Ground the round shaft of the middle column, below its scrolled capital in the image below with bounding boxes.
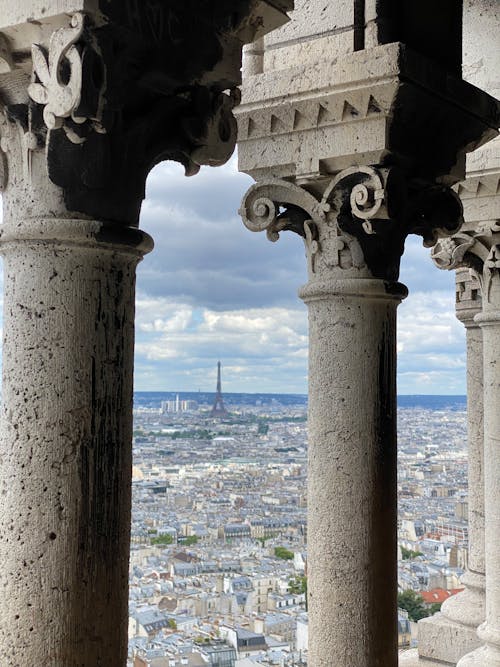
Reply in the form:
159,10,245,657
301,279,404,667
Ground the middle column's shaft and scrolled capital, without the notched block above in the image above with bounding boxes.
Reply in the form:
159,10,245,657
241,166,461,667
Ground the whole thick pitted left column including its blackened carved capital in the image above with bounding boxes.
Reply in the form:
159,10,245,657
0,0,290,667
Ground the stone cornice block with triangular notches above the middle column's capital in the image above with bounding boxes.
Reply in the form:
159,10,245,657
237,44,500,185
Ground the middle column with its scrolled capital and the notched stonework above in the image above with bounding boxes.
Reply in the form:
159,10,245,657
237,0,497,667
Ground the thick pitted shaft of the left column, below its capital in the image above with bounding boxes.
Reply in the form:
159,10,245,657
0,220,147,667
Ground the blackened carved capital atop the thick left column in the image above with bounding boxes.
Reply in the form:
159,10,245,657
0,0,292,225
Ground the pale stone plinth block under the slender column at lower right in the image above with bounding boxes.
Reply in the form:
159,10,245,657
418,614,481,665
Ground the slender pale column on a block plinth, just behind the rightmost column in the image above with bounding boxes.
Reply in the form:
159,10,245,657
418,268,485,665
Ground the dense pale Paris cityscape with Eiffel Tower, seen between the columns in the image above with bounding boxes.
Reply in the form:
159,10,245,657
129,374,468,667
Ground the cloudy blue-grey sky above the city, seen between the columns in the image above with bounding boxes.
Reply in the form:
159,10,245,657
0,157,466,394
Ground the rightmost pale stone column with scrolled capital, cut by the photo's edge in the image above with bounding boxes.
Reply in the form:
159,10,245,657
433,219,500,667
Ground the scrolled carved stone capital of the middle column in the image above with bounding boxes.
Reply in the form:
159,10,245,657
240,166,462,281
